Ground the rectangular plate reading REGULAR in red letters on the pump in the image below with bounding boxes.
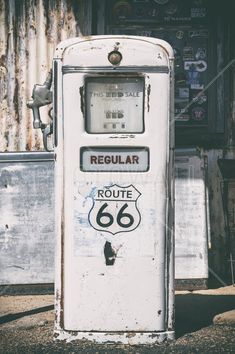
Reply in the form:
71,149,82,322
80,147,149,172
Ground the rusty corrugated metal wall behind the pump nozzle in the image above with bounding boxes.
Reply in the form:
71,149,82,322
0,0,91,152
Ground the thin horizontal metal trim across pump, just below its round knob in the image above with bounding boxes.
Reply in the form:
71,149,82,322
62,65,170,74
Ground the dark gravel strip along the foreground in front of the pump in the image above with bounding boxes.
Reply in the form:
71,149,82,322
0,324,235,354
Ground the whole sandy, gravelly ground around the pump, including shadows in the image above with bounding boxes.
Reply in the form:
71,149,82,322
0,286,235,354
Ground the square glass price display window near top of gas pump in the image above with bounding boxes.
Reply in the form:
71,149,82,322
85,77,144,134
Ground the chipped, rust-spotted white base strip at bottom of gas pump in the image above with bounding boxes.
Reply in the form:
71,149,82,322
54,330,175,345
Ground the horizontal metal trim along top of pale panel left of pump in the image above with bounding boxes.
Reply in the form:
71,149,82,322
0,151,55,163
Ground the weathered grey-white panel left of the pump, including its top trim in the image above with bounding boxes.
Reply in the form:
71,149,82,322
0,152,55,285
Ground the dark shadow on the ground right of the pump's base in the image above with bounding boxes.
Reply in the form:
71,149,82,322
175,294,235,338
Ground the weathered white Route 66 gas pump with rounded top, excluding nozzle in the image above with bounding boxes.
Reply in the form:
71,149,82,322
53,36,174,344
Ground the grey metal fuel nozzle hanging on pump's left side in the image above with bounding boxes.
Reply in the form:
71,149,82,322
27,70,53,151
